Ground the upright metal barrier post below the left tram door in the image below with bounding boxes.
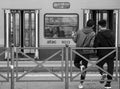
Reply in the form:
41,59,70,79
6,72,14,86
10,47,14,89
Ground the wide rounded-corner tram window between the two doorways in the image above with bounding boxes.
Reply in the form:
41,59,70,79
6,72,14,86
44,14,79,39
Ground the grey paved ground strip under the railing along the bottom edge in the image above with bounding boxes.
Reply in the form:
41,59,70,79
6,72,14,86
0,82,120,89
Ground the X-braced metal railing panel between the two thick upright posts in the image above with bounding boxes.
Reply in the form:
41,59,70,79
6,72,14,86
15,47,64,82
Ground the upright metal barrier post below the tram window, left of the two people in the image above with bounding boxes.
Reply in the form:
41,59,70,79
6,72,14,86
65,45,69,89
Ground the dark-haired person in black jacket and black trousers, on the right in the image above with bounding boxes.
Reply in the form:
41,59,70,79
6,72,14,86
94,20,115,88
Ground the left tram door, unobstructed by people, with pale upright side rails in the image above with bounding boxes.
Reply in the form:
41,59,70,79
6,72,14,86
4,9,39,57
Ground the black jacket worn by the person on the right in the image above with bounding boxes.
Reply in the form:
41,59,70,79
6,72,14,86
94,29,115,57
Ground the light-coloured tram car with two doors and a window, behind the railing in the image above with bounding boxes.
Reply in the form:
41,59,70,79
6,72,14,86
0,0,120,60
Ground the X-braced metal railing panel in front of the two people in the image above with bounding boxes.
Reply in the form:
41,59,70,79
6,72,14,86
70,47,118,81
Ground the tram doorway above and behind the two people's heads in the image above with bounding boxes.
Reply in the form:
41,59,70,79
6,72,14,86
83,9,118,35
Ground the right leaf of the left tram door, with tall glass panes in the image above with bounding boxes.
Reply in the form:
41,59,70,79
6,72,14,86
24,13,35,47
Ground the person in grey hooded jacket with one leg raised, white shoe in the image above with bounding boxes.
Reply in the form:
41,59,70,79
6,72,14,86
73,19,95,88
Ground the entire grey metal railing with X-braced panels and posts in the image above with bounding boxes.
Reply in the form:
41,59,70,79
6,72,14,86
0,45,118,89
